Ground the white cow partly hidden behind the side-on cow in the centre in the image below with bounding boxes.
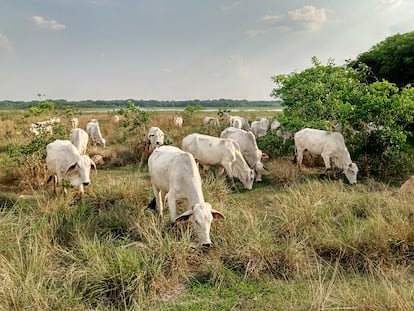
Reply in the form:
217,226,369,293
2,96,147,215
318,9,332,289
220,127,268,181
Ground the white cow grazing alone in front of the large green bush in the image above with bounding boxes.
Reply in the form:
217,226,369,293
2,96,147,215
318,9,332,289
294,128,358,184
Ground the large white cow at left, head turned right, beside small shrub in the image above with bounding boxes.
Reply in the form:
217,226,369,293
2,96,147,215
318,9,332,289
46,139,96,196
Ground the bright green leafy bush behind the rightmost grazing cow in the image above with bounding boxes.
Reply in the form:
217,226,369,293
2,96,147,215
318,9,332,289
273,58,414,177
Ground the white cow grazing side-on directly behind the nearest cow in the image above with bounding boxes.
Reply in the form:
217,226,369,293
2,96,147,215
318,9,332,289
182,133,254,190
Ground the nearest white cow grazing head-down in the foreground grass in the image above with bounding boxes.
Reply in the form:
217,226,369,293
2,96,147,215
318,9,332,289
148,146,224,247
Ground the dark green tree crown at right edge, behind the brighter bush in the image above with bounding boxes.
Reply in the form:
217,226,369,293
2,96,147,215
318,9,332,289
351,31,414,87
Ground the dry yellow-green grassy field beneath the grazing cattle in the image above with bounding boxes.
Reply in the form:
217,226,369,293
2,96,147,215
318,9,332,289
0,111,414,311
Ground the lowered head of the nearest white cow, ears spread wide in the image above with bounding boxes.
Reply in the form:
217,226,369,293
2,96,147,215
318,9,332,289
175,203,225,247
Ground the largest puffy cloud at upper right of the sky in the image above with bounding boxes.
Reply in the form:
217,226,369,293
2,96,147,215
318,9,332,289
288,5,328,32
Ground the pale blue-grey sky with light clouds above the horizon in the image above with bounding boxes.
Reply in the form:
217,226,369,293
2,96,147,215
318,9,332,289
0,0,414,101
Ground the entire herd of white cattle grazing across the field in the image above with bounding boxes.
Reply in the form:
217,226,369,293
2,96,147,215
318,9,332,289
30,114,358,246
